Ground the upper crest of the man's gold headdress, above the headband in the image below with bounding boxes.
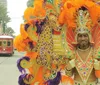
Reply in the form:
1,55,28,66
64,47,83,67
76,7,92,32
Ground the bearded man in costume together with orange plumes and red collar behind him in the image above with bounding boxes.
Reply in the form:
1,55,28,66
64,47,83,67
59,0,100,85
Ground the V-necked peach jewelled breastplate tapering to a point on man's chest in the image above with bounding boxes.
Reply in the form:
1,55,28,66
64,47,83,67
75,49,93,84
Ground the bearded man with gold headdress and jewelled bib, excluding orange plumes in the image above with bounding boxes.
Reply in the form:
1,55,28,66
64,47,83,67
66,7,96,85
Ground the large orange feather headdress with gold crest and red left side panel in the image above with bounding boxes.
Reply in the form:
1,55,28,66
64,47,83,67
59,0,100,49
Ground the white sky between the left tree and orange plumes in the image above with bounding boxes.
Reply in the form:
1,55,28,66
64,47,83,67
7,0,28,35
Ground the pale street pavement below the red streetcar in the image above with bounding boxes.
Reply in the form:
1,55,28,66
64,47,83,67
0,51,25,85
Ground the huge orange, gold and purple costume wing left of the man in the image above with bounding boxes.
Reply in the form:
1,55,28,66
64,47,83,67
14,0,72,85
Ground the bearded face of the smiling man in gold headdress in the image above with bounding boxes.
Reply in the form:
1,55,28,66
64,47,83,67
77,33,89,48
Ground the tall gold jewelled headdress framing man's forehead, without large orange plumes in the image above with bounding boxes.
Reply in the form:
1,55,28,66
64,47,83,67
75,6,93,39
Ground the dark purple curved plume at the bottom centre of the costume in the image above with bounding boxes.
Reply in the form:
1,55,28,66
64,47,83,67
46,71,61,85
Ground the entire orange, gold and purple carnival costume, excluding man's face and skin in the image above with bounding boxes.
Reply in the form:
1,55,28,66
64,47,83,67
14,0,100,85
